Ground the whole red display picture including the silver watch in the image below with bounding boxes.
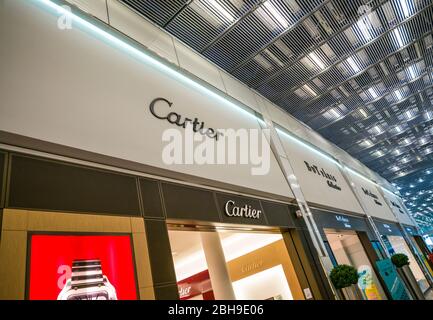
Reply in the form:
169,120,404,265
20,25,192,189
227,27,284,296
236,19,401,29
27,234,137,300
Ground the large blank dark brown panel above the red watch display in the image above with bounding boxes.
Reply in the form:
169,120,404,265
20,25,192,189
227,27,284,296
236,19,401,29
7,155,140,216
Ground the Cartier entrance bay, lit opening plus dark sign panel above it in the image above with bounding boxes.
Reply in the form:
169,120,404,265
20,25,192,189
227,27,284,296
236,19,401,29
162,183,330,300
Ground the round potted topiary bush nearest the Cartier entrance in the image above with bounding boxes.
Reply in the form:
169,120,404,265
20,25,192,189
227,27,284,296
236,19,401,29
329,264,362,300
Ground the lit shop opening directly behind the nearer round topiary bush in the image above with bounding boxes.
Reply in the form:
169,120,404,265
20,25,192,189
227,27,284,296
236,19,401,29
324,229,387,300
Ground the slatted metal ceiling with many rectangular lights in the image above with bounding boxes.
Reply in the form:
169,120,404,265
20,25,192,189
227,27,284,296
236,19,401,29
122,0,433,230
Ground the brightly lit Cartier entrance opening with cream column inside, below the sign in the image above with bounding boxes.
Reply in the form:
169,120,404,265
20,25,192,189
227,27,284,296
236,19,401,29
169,225,303,300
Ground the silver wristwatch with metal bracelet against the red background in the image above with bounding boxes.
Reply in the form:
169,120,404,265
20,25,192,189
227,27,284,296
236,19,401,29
57,259,117,300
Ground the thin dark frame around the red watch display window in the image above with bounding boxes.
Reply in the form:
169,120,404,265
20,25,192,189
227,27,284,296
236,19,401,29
24,231,140,300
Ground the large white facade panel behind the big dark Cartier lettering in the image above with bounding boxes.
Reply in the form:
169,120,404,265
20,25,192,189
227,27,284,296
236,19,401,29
0,1,293,198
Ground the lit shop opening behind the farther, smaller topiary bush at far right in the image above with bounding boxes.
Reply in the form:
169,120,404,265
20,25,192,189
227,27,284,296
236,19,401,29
382,235,429,292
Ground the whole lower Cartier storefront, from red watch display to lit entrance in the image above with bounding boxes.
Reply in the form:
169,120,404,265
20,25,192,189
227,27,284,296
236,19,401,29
0,151,329,300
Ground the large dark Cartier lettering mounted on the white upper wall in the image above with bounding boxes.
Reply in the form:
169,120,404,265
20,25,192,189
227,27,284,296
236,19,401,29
149,98,223,141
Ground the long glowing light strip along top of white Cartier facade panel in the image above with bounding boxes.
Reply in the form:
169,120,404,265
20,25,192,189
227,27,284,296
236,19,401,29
36,0,261,125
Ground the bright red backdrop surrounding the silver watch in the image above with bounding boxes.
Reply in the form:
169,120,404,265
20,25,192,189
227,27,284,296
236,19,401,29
28,235,137,300
